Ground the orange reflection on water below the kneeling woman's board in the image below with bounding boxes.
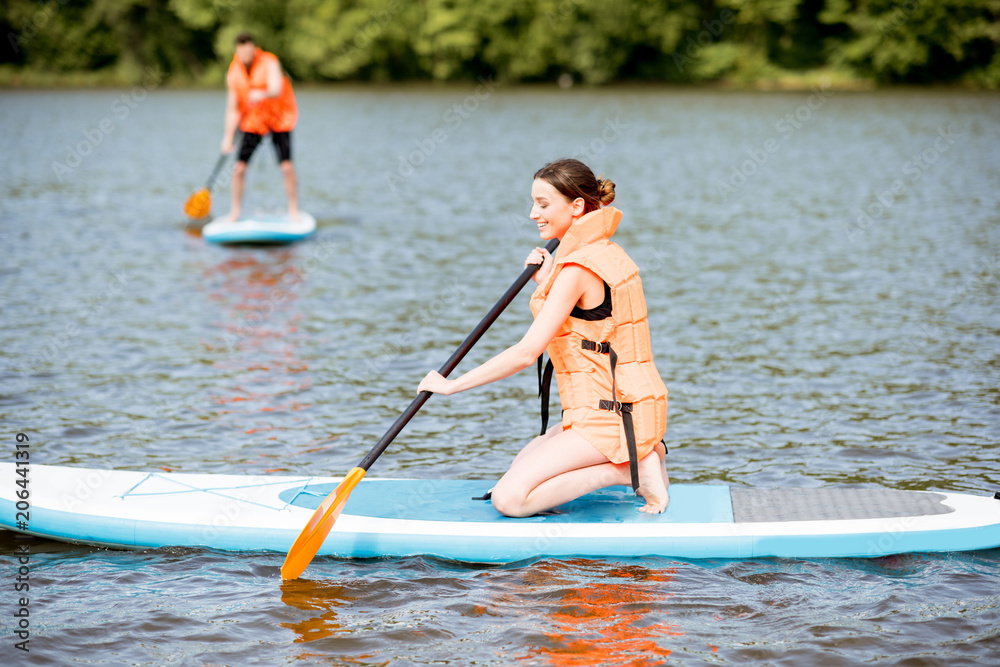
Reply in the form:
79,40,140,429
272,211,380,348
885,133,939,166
520,561,684,667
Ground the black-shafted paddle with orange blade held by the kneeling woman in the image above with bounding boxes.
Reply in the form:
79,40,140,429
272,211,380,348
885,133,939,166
281,239,559,581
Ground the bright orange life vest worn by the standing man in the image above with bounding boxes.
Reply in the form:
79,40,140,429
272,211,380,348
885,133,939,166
226,47,299,135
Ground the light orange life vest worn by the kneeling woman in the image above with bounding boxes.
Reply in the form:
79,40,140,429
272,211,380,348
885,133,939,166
531,207,667,463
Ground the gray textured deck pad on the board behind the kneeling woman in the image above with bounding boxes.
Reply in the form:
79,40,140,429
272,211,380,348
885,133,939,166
730,487,955,522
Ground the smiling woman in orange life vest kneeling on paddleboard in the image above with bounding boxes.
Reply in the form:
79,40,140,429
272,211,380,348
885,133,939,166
418,159,670,517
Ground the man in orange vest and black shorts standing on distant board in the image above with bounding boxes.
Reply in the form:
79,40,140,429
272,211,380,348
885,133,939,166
222,32,299,220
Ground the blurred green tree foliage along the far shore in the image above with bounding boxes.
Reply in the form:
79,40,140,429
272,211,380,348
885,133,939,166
0,0,1000,89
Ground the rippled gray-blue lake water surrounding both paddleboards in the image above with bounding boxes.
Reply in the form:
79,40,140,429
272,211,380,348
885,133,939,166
0,82,1000,666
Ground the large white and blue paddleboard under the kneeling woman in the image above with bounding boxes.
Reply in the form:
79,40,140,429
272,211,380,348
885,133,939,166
0,463,1000,563
